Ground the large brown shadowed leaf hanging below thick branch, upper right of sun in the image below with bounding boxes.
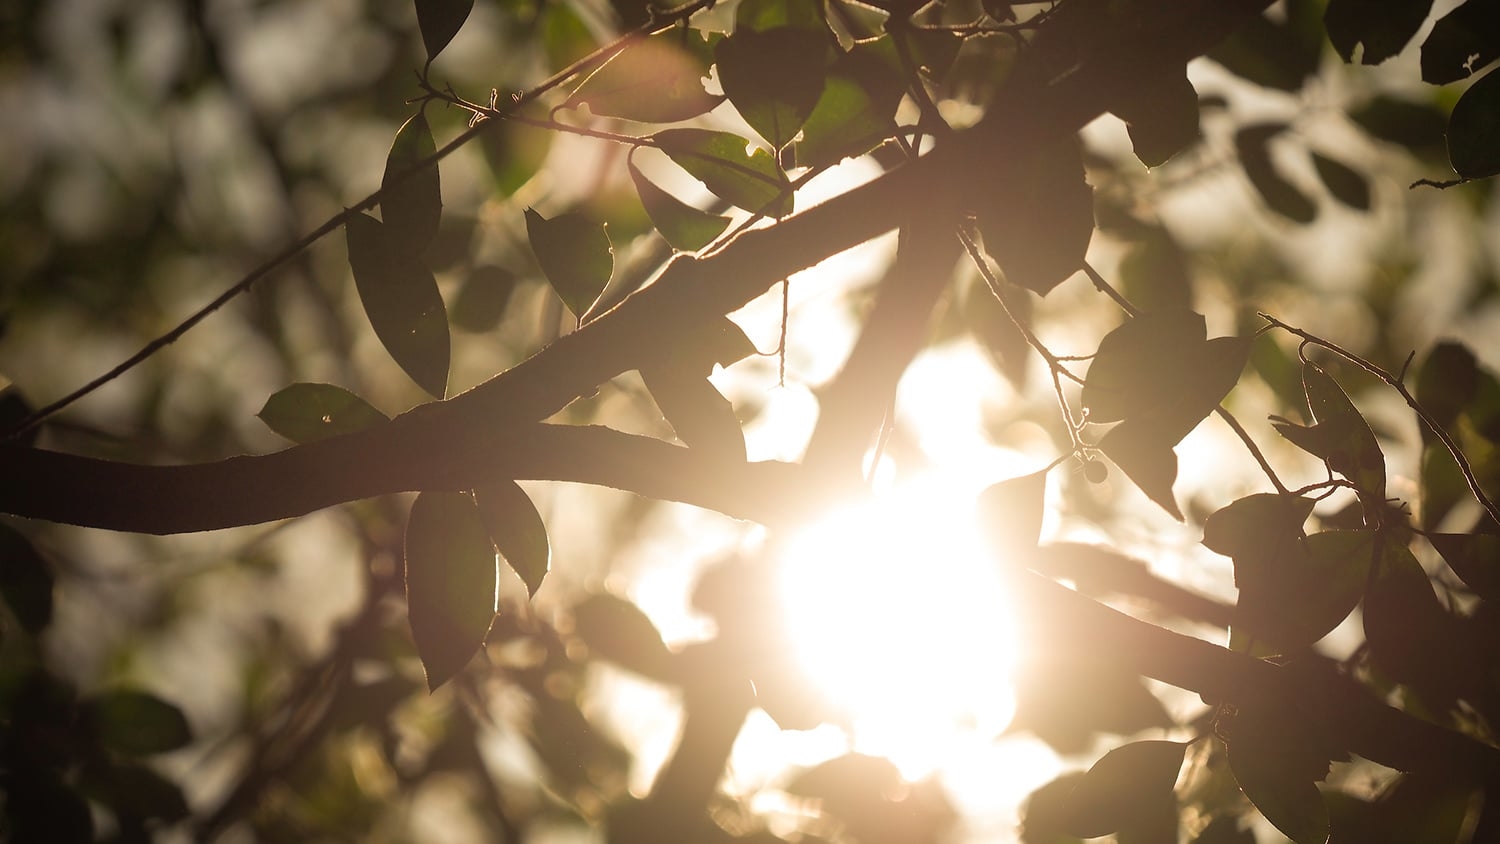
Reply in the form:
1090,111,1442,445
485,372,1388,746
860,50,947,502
980,138,1094,295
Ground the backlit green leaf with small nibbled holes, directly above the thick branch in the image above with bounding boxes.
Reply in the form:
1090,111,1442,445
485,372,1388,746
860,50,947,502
651,129,792,217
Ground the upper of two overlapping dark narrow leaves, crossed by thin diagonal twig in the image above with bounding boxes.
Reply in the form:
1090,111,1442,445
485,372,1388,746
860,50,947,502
380,111,443,256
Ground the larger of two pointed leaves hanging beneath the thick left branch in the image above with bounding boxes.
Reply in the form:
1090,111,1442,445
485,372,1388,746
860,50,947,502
405,490,500,691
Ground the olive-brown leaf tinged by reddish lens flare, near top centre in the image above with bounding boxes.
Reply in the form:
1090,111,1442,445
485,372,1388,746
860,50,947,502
563,30,722,123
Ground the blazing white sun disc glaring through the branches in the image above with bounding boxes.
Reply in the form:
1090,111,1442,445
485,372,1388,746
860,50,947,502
782,467,1016,778
